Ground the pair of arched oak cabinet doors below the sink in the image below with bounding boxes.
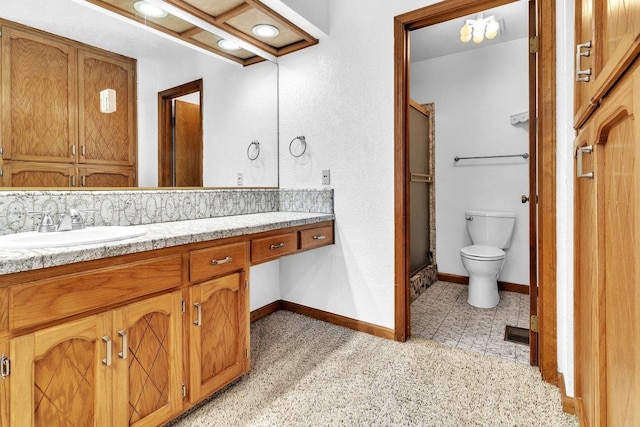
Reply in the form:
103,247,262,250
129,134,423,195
10,291,182,426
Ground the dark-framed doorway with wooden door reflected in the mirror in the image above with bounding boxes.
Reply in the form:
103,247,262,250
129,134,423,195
158,79,203,187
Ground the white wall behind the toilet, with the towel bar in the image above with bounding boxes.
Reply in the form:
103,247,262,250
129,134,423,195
410,38,529,285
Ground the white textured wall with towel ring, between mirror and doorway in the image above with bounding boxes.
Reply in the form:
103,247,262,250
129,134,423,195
279,0,442,328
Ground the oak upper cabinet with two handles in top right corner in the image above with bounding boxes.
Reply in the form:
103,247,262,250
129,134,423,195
574,0,640,129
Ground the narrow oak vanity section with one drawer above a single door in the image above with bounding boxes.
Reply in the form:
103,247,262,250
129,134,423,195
186,242,250,404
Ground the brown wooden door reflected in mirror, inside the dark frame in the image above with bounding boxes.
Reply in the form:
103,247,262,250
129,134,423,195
174,100,202,187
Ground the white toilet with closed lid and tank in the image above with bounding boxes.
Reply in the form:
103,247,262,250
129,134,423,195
460,211,516,308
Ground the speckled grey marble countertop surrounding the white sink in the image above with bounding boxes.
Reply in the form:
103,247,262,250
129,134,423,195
0,212,335,275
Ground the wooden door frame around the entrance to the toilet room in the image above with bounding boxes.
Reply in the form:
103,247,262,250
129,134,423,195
394,0,558,384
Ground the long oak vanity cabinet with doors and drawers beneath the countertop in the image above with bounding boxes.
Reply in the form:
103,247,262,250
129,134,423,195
0,221,333,427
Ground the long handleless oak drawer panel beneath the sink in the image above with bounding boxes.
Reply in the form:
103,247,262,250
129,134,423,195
9,255,182,329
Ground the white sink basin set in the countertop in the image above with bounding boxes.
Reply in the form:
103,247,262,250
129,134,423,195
0,225,147,249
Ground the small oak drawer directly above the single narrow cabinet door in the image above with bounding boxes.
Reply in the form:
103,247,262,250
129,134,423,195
189,243,247,282
